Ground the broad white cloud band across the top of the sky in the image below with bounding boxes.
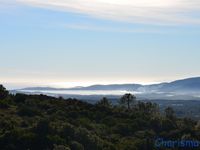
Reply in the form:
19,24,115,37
12,0,200,24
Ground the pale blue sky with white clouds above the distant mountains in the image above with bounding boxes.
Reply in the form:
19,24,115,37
0,0,200,89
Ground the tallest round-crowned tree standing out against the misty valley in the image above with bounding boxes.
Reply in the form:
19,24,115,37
119,93,136,110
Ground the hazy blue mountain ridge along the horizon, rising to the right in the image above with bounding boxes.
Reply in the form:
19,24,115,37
20,77,200,93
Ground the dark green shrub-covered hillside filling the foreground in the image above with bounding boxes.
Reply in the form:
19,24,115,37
0,86,200,150
